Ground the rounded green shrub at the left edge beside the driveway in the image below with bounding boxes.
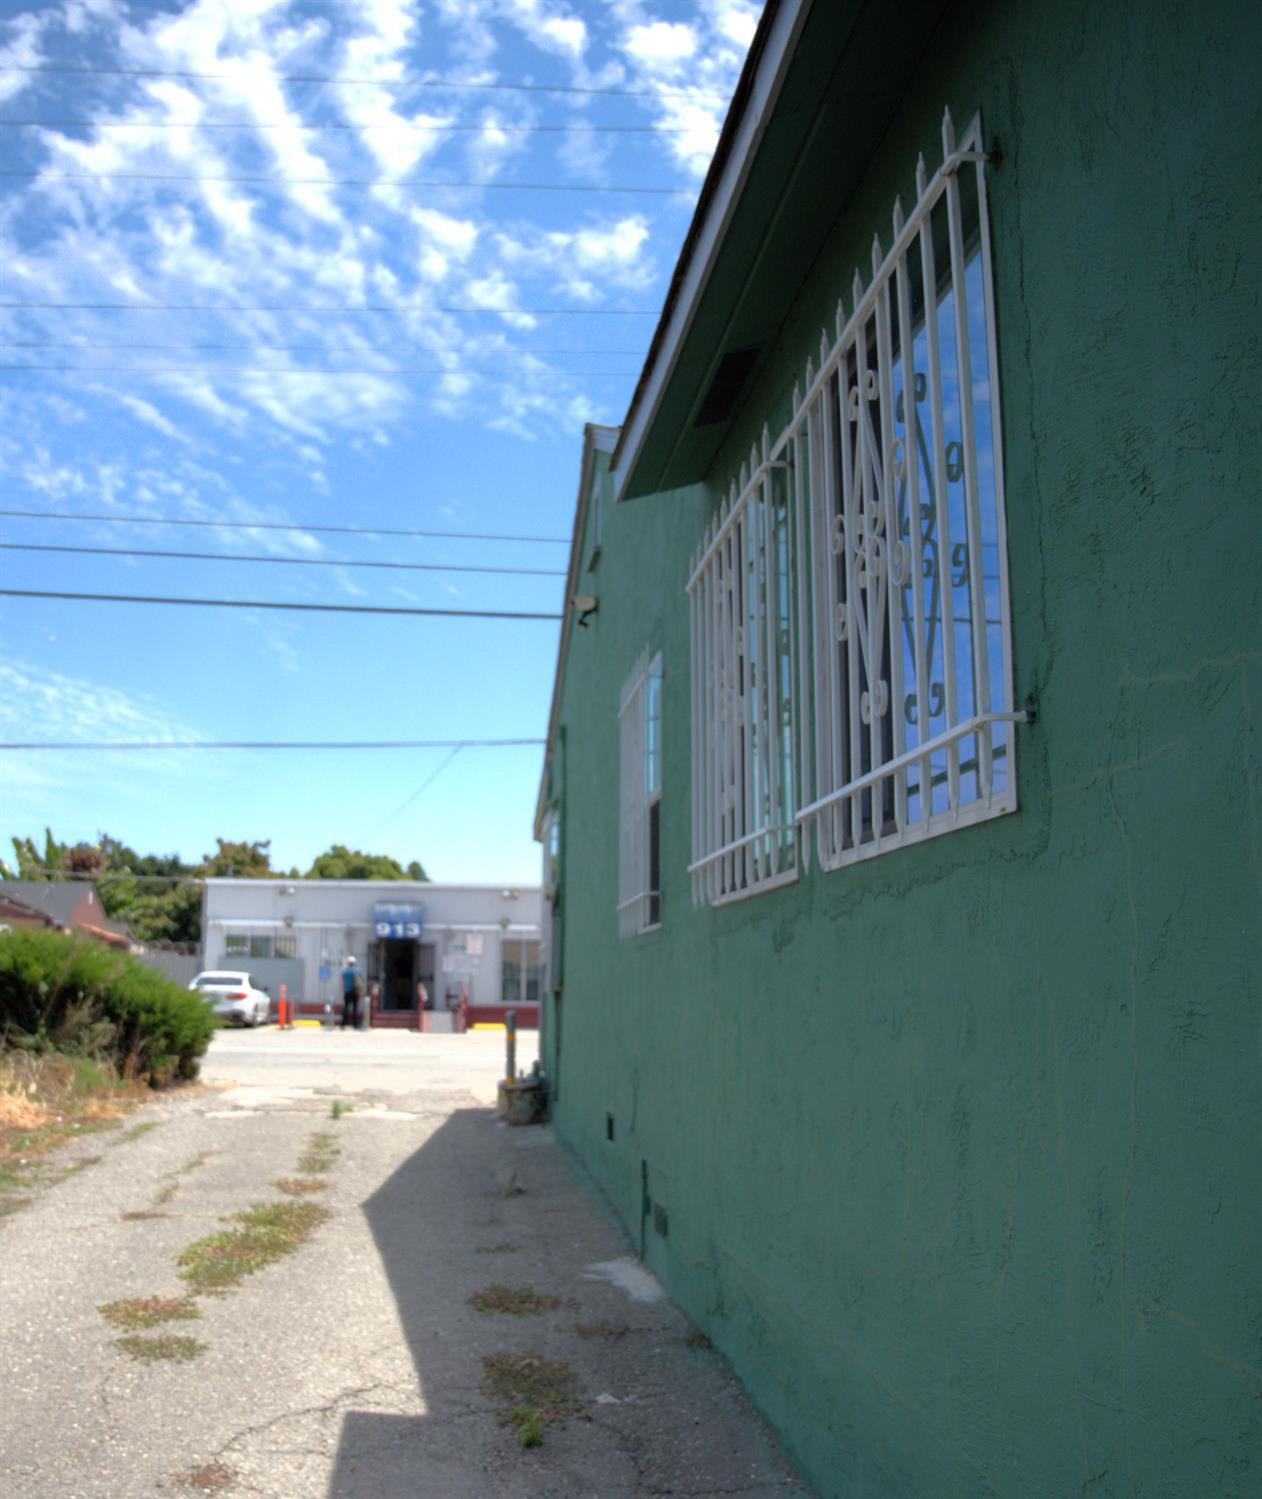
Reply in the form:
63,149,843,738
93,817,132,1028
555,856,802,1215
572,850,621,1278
0,928,214,1085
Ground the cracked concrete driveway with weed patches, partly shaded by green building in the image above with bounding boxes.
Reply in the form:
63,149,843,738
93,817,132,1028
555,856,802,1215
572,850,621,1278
0,1030,805,1499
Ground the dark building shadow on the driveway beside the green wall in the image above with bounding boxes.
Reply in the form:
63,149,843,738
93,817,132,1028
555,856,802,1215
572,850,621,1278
328,1108,803,1499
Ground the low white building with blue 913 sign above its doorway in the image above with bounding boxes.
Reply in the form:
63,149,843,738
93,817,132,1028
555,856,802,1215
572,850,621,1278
202,878,543,1030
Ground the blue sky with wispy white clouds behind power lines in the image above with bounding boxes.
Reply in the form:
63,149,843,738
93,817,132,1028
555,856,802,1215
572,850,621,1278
0,0,760,883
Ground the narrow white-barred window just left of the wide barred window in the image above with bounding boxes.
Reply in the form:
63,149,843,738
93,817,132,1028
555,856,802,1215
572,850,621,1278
618,651,661,937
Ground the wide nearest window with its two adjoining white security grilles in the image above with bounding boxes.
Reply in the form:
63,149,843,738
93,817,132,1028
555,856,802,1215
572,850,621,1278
689,112,1025,902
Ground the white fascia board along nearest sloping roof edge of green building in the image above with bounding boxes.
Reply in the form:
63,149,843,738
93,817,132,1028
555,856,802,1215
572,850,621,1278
613,0,811,502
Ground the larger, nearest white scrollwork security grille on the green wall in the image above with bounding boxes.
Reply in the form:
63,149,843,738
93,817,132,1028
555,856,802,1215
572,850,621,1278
781,112,1025,869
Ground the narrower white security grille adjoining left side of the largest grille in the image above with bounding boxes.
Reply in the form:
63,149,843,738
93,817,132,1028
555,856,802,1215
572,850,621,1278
688,430,800,905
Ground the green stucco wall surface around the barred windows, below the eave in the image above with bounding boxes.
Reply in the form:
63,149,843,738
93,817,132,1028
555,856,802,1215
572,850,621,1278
547,0,1262,1499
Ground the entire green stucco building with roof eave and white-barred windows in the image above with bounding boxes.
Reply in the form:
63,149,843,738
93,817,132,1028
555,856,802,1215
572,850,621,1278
537,0,1262,1499
